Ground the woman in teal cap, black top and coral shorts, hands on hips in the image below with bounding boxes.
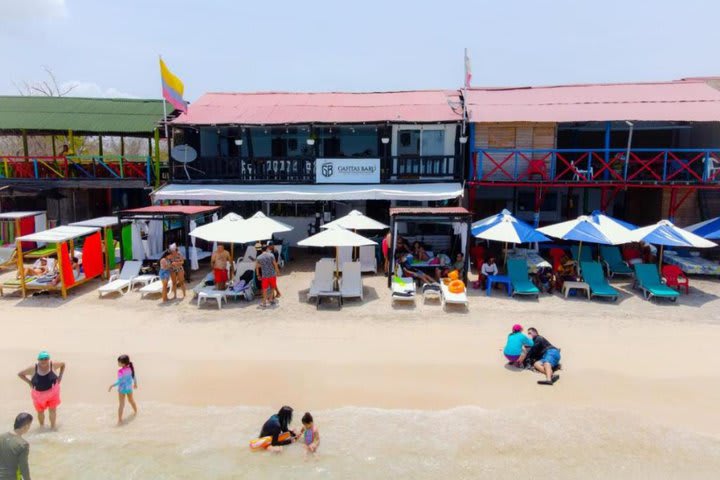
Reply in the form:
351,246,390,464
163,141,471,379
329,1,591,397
18,350,65,429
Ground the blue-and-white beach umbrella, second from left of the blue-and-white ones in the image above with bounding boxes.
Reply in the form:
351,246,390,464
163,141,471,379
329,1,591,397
538,211,634,265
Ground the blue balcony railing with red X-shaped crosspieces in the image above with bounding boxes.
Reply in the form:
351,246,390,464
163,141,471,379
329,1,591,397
470,148,720,184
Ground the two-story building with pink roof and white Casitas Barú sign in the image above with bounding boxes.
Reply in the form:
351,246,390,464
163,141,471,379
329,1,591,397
154,90,468,244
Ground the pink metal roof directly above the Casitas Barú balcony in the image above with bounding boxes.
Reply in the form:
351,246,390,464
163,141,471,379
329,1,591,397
172,90,462,125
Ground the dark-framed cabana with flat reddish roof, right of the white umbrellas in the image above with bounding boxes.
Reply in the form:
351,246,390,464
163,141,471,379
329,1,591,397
388,207,472,287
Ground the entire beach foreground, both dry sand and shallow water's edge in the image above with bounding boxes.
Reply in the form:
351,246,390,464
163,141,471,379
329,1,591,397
0,260,720,479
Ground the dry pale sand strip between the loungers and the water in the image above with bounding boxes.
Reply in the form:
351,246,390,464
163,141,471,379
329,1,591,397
0,255,720,478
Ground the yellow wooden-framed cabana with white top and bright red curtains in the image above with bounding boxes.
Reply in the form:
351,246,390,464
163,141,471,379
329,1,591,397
15,226,103,298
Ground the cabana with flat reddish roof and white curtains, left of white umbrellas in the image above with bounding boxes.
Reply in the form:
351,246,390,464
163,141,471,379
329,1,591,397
118,205,220,280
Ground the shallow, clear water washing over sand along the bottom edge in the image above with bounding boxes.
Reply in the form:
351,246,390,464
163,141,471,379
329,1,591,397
9,404,720,480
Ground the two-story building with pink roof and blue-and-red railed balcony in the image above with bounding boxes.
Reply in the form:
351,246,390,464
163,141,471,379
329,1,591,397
464,78,720,225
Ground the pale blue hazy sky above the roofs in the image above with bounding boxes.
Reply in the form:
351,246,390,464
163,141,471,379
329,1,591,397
0,0,720,101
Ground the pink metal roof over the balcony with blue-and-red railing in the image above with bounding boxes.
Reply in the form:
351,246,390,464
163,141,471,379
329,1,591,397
465,79,720,122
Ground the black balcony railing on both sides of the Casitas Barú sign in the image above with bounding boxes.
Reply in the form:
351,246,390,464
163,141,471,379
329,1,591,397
177,155,463,183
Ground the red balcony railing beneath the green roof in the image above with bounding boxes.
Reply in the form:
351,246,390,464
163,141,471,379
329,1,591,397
0,155,153,185
